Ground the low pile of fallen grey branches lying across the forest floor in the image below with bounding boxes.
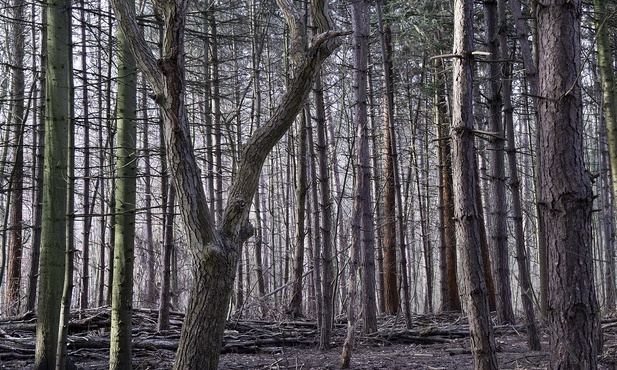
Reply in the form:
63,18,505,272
0,307,478,369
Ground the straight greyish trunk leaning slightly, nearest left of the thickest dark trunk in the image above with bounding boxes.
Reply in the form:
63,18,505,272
450,0,497,370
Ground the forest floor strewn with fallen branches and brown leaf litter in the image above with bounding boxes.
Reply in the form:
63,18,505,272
0,309,617,370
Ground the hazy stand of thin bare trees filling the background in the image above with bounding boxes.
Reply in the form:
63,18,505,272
0,0,617,368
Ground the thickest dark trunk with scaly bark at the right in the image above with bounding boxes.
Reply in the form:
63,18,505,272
538,0,602,369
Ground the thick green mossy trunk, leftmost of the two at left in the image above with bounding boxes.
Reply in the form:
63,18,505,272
34,0,72,370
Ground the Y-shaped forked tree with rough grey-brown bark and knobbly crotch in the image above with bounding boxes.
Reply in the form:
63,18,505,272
112,0,341,369
